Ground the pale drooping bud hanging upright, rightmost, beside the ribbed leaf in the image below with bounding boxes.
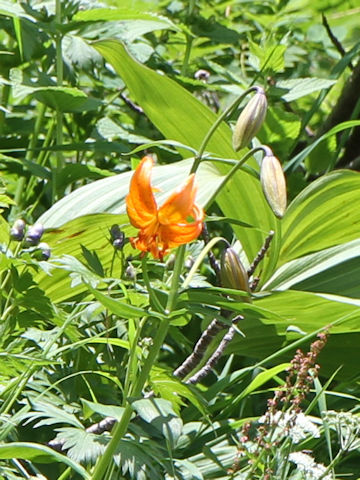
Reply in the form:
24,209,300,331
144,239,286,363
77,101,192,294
260,154,287,218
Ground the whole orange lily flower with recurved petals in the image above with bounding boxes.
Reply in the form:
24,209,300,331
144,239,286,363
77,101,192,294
126,156,204,260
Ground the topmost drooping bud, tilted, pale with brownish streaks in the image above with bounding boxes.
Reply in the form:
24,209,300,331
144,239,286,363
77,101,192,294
233,87,267,152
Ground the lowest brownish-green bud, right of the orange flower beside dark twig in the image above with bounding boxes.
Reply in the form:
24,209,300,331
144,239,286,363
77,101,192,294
220,247,251,302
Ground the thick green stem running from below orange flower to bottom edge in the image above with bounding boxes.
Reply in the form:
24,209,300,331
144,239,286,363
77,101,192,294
91,245,185,480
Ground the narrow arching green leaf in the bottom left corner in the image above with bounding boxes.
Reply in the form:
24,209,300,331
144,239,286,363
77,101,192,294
0,442,90,480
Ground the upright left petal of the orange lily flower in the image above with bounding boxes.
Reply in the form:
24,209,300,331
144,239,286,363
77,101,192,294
126,156,157,228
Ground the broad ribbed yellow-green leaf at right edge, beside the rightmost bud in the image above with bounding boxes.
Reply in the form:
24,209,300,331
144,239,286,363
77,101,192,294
279,170,360,265
